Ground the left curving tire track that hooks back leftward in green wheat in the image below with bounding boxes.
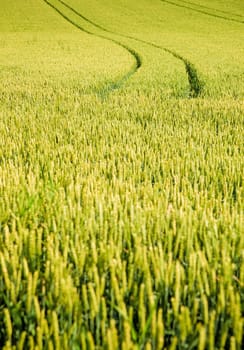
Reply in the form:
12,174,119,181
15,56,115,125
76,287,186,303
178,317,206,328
43,0,142,97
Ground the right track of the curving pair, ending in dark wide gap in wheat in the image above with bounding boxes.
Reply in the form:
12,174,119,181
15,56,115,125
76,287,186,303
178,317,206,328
55,0,204,98
